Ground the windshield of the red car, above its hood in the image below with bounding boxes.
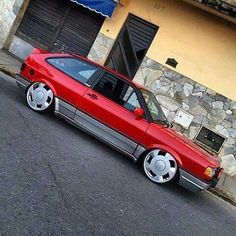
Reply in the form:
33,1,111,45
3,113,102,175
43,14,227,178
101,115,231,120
141,89,168,124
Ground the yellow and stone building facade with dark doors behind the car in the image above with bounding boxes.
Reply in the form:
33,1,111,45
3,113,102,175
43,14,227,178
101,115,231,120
0,0,236,199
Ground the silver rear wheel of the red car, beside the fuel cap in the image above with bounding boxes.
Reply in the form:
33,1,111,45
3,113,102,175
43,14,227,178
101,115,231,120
26,82,53,111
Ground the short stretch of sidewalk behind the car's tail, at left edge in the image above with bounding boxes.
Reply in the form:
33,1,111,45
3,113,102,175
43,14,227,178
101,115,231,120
0,50,22,77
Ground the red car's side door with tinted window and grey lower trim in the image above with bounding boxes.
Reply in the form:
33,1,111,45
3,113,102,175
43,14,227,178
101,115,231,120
75,72,149,154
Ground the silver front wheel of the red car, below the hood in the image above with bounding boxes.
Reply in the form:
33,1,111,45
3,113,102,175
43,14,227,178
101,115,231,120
143,149,178,184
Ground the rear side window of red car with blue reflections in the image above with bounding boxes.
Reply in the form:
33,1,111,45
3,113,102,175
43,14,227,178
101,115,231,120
47,57,98,84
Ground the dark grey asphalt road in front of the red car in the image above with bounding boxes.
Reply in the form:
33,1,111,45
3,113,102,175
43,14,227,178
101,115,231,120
0,74,236,236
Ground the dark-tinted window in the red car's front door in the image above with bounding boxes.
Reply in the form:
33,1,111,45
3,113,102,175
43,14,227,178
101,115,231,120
94,73,140,111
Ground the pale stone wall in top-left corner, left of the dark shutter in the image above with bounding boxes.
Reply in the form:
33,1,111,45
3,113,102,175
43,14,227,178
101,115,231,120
0,0,23,48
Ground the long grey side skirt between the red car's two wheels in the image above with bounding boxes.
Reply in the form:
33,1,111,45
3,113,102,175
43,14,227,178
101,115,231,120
55,98,146,161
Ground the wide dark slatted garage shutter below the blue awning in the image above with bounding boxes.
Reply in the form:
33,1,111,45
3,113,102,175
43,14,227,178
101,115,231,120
17,0,105,56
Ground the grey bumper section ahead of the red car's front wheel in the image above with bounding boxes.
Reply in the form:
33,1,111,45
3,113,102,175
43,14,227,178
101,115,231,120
179,169,210,192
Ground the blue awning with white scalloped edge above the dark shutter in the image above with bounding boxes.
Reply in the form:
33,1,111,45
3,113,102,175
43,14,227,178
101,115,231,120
71,0,117,18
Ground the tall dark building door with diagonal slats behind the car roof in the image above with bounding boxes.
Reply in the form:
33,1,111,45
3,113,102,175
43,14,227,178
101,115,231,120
105,14,159,80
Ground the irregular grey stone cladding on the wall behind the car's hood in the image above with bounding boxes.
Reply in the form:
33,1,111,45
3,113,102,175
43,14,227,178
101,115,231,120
134,57,236,176
